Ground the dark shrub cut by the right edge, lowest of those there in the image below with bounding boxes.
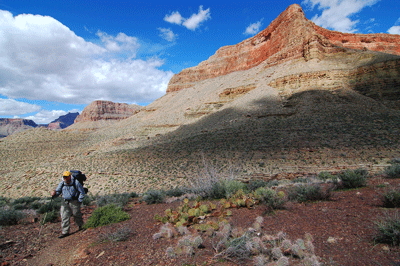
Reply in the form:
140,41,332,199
375,211,400,245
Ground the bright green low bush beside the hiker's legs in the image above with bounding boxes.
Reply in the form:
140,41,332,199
84,204,129,229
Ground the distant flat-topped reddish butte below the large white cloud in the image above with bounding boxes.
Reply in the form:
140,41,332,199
75,101,141,123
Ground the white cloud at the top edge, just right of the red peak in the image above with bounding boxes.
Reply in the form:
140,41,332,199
302,0,379,32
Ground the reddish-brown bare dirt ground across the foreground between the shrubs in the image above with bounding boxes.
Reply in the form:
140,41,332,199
0,177,400,266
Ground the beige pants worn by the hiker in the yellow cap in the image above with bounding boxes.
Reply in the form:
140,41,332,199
60,200,83,234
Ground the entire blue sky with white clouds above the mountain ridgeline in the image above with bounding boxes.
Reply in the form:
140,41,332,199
0,0,400,124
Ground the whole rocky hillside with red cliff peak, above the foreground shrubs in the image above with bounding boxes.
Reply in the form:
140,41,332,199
0,5,400,200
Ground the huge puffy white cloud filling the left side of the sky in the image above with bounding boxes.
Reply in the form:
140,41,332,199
0,10,173,109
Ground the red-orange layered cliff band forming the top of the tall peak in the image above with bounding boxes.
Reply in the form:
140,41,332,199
167,4,400,93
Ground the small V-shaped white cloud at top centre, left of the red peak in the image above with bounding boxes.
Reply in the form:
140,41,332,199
164,6,211,31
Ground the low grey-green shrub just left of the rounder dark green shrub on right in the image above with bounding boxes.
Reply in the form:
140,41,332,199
287,184,331,202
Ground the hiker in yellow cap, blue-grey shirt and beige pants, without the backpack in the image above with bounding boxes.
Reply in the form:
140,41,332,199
51,171,85,238
